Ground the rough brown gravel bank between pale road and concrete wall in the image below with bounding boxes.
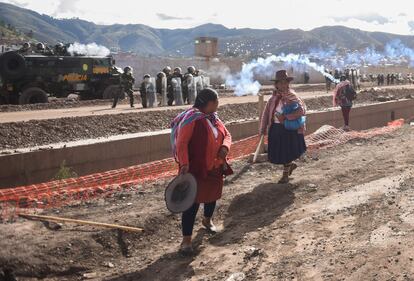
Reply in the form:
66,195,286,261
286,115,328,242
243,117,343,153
0,87,414,153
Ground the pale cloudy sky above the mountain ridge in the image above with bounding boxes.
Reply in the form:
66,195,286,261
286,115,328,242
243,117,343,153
0,0,414,35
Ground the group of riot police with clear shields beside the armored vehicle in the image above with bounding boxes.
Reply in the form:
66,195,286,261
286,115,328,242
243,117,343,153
112,66,210,108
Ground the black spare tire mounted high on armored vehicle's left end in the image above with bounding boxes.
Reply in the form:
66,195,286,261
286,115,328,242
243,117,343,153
0,52,26,80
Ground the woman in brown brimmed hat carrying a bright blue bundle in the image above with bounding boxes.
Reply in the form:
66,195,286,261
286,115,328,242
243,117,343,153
260,70,306,184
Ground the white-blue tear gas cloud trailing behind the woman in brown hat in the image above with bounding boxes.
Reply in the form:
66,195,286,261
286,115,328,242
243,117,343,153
226,40,414,96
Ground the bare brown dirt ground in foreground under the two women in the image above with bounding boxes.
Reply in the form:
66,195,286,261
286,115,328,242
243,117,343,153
0,125,414,281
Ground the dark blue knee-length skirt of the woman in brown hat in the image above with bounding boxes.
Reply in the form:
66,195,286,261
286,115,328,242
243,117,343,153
268,123,306,164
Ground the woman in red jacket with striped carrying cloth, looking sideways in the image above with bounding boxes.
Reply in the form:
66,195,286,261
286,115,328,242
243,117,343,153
171,89,231,254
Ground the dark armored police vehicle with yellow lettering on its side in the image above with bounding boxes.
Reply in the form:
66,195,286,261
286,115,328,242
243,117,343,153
0,47,122,104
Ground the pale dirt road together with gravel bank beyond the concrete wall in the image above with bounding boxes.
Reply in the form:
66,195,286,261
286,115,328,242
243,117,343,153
0,85,414,150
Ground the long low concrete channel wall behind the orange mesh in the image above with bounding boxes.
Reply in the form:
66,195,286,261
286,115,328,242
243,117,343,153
0,100,414,188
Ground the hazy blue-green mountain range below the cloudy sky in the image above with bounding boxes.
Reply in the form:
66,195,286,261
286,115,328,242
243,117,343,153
0,3,414,56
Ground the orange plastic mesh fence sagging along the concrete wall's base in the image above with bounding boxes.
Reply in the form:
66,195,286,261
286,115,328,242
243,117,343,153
0,119,404,220
